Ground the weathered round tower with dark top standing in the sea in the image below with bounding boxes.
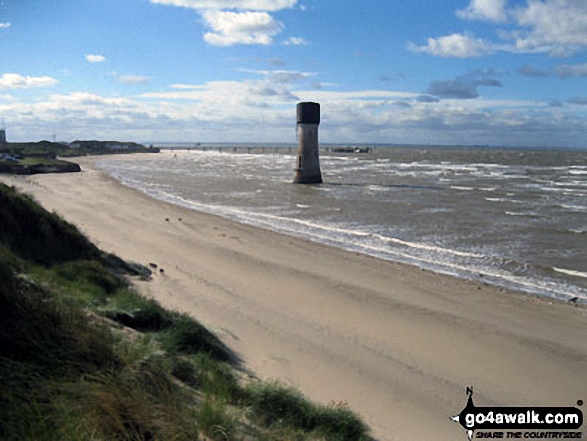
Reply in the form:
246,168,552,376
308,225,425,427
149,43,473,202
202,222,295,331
294,103,322,184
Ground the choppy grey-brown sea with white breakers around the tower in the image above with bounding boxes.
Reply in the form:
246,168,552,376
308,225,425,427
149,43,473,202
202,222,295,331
97,144,587,303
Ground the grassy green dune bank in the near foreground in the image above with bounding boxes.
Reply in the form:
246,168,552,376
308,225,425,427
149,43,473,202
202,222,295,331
0,180,368,440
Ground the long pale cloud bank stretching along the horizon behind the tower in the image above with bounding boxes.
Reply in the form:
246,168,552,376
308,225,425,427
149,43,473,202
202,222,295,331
0,84,587,146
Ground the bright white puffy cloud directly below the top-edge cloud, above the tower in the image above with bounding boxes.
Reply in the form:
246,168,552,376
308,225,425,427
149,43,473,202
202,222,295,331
202,10,283,46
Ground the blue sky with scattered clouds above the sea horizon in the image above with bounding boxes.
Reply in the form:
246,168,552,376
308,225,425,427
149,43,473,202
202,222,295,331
0,0,587,148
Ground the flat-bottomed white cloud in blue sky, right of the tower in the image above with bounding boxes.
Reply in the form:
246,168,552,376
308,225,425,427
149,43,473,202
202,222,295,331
408,34,494,58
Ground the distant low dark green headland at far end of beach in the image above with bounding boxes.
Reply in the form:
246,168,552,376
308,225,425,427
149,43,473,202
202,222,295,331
0,141,159,175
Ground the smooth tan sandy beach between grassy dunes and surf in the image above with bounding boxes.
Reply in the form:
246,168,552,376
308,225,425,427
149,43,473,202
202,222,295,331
0,156,587,440
